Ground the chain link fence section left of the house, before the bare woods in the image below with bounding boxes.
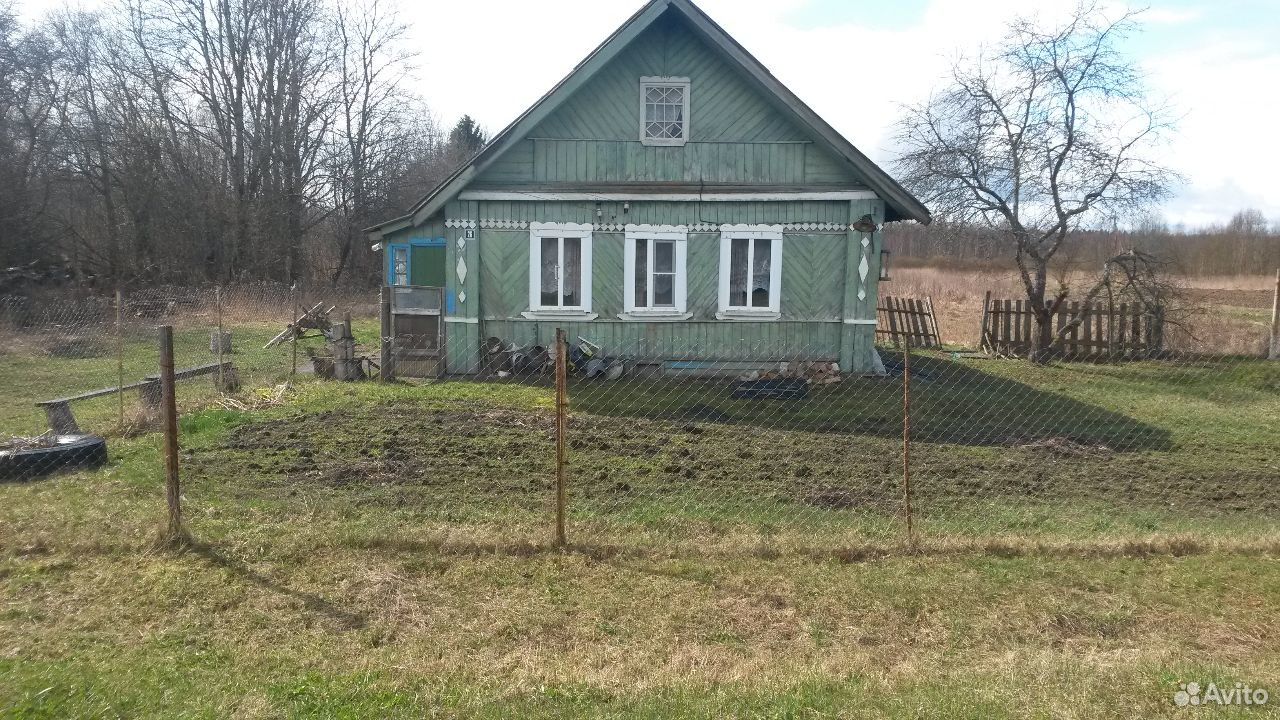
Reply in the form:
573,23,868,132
0,283,378,479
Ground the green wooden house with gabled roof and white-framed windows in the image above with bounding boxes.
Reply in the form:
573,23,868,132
369,0,929,374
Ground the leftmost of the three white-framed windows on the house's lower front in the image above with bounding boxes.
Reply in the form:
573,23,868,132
529,223,591,315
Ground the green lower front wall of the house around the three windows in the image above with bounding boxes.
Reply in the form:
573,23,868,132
417,200,883,373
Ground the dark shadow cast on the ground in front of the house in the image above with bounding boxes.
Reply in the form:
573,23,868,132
570,351,1172,451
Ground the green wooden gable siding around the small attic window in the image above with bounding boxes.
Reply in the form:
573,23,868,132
472,16,864,187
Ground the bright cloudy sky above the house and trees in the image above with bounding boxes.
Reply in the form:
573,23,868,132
18,0,1280,227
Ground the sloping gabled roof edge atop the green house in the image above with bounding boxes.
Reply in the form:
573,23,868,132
367,0,929,236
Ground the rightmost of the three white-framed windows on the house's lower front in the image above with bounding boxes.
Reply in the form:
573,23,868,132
717,225,782,319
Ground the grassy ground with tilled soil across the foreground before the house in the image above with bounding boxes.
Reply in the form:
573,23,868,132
0,356,1280,719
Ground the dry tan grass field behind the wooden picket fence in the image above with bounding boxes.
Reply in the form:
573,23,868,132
882,268,1275,356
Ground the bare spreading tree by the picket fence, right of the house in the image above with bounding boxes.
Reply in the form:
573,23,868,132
896,4,1178,361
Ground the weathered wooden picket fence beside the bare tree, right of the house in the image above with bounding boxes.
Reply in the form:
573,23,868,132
982,292,1164,360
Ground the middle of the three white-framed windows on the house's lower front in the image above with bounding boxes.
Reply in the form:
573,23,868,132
622,225,689,319
